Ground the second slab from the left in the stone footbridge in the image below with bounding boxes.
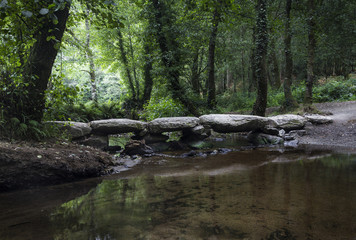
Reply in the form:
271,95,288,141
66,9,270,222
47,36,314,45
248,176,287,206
90,119,147,135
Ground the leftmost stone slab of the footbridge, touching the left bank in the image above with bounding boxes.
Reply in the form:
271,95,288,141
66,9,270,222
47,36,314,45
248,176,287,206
46,121,92,139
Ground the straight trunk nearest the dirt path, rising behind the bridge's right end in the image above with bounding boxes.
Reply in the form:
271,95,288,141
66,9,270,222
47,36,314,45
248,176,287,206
304,0,316,106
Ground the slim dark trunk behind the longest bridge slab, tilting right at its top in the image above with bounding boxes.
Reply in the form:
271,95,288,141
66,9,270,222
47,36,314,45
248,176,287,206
207,8,220,108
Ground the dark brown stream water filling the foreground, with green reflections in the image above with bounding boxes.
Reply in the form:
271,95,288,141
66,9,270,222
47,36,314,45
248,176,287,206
0,150,356,240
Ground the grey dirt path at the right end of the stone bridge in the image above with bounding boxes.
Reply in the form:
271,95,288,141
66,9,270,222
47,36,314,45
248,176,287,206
299,101,356,151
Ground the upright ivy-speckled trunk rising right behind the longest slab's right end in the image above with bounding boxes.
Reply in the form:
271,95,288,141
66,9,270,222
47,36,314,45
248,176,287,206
252,0,268,116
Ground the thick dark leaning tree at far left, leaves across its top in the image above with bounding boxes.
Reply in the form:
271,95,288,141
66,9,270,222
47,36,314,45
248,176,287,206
14,1,70,122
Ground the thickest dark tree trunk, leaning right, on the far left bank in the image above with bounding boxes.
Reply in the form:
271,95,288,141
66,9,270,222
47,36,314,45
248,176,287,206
22,1,70,122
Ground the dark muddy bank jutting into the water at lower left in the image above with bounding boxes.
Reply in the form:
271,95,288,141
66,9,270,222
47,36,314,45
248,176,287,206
0,141,113,192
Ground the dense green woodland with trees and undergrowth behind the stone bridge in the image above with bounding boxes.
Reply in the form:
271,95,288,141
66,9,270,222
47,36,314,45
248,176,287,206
0,0,356,138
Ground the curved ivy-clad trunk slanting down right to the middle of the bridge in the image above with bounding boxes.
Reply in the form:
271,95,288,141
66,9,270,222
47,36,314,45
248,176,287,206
151,0,200,116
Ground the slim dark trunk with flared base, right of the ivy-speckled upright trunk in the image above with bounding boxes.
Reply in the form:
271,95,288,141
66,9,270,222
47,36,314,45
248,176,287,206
283,0,298,109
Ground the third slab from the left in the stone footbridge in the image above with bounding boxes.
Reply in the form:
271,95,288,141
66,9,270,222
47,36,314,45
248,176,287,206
148,117,199,134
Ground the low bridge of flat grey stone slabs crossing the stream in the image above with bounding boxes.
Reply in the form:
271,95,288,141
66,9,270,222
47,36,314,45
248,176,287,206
50,114,332,149
